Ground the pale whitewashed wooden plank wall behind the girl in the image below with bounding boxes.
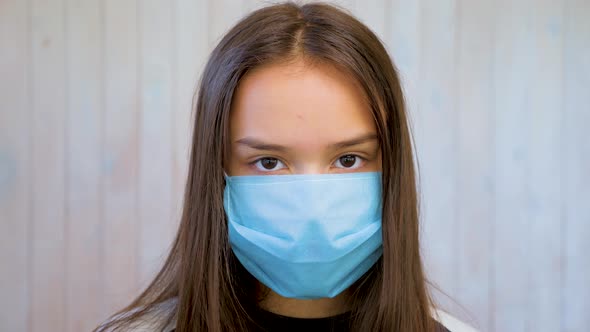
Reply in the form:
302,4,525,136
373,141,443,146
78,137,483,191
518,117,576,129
0,0,590,332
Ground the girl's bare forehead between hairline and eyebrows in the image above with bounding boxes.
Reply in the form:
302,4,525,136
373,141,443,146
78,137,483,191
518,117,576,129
230,61,375,144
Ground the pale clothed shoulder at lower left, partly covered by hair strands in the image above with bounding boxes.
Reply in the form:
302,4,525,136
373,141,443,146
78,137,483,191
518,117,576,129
96,298,177,332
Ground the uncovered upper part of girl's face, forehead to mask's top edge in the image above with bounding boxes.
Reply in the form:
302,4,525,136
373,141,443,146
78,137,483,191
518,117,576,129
226,61,381,176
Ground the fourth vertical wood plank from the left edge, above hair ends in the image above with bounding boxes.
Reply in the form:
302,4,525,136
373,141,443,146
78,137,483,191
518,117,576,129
101,0,140,319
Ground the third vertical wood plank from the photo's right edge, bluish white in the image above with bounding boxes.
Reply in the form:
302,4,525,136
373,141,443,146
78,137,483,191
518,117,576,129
489,0,535,332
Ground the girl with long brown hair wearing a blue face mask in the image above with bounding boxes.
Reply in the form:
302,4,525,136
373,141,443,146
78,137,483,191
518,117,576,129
97,3,476,332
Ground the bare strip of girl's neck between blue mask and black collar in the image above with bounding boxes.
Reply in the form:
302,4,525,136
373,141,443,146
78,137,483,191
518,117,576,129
258,284,350,318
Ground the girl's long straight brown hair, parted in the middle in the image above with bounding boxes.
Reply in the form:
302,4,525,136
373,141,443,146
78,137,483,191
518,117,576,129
97,2,433,332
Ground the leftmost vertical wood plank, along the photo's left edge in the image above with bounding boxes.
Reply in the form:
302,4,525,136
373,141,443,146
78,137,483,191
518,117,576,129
0,0,31,331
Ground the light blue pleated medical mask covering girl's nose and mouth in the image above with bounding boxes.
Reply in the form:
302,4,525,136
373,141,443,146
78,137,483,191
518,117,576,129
224,172,383,299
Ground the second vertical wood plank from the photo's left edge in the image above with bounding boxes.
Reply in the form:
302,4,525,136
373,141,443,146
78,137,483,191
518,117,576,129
29,0,67,331
